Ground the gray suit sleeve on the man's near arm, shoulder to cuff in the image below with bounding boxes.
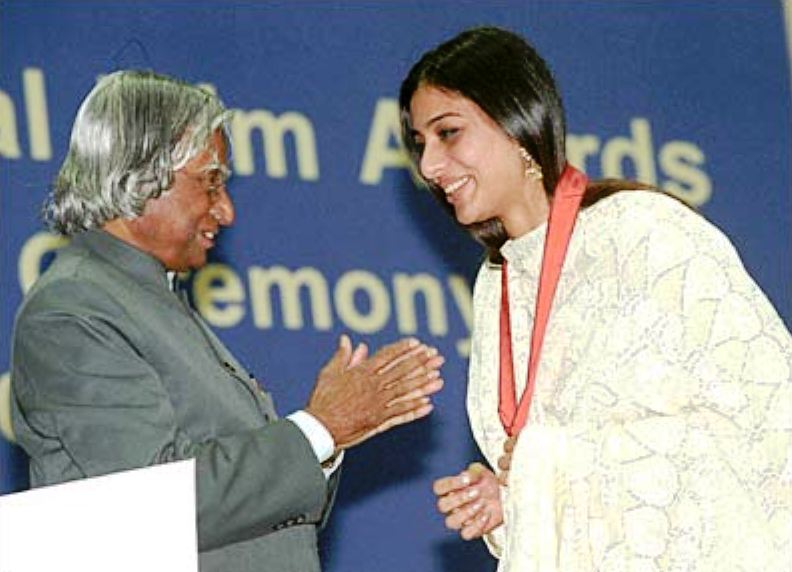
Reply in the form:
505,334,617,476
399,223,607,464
12,311,335,550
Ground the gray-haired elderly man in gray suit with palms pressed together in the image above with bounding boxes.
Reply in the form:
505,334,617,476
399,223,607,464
12,71,443,572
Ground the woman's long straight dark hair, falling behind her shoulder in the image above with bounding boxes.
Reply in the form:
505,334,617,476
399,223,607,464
399,27,653,263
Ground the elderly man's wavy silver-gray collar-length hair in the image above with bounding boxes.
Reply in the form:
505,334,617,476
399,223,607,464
44,70,229,236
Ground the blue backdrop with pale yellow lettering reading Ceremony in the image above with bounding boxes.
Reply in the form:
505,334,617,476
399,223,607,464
0,0,792,572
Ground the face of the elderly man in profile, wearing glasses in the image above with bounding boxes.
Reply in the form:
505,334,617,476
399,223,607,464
126,130,234,272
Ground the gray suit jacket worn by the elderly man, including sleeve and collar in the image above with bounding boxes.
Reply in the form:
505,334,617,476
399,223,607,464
12,231,336,572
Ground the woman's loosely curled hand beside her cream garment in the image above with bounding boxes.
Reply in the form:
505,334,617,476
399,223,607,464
433,463,503,540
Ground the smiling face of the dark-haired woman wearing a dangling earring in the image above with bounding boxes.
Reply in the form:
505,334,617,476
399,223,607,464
410,85,547,237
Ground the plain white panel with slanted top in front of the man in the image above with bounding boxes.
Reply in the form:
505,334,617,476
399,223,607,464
0,460,198,572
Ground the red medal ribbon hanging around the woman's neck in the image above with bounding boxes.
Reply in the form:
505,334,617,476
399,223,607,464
498,165,588,437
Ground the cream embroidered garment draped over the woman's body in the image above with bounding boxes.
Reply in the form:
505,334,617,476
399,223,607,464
468,191,792,572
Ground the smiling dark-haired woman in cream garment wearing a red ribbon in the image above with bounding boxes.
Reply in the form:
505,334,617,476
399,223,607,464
399,28,792,572
